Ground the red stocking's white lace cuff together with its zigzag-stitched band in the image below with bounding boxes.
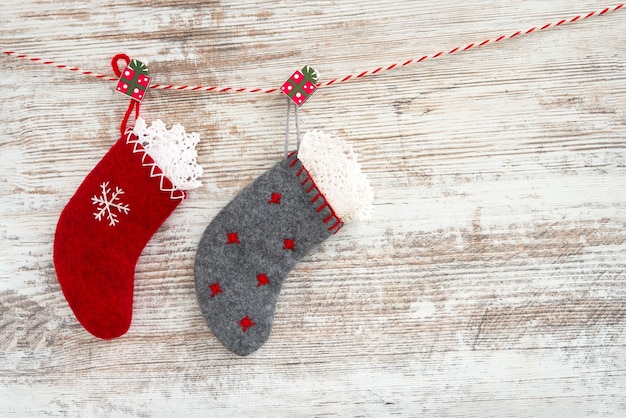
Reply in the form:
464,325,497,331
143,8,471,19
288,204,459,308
126,118,202,200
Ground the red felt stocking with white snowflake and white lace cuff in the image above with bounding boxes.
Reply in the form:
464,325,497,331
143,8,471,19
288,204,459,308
54,118,202,339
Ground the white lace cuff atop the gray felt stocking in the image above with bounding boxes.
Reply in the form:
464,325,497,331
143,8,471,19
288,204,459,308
298,131,374,222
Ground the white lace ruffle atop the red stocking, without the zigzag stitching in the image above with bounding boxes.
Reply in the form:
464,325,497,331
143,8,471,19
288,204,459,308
133,118,202,190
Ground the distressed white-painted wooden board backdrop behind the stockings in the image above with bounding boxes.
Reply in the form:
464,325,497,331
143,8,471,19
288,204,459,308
0,0,626,417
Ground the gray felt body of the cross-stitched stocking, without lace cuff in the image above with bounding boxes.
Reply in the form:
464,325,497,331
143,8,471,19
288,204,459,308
194,153,341,356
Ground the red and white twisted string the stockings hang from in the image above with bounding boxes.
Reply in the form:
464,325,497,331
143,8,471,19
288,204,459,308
0,3,626,94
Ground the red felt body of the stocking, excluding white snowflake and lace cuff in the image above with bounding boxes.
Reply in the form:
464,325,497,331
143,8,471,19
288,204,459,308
53,135,184,339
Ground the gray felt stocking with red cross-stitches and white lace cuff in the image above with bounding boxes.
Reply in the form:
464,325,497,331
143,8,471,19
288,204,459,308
194,131,373,356
